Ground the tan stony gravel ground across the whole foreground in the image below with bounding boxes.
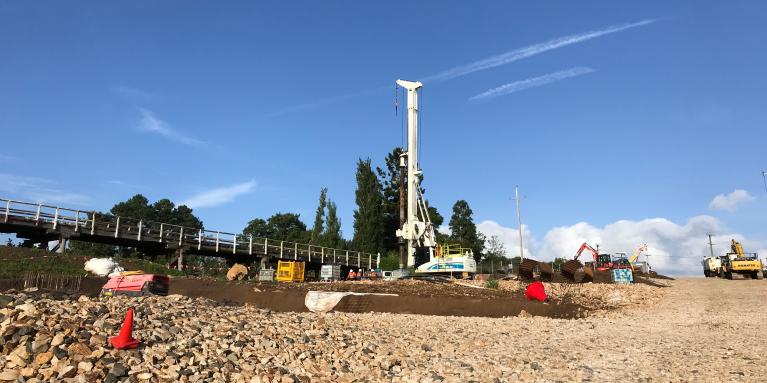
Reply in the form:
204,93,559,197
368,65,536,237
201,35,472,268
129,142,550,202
0,279,767,382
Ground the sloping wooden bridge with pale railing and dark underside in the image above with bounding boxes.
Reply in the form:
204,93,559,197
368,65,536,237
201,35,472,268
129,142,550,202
0,198,378,269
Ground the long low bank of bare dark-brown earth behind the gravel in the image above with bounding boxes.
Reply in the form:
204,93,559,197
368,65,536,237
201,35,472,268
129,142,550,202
170,278,588,319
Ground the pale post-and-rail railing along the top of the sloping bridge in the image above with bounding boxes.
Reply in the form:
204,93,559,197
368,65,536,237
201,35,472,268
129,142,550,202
0,198,376,268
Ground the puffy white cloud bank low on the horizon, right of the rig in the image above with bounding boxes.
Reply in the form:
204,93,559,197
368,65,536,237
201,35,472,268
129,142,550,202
478,215,767,275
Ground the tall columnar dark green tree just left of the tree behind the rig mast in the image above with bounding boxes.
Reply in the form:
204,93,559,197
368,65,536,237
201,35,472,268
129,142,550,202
352,158,386,253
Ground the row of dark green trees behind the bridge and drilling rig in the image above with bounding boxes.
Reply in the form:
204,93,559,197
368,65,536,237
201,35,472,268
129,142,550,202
64,148,485,267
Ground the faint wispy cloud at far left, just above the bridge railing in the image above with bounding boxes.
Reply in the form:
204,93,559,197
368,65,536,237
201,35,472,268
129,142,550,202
0,173,90,205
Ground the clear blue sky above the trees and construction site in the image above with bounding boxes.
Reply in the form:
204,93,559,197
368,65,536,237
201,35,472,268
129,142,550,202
0,1,767,272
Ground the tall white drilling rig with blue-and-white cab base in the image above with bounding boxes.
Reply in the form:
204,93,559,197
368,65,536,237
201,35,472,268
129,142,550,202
397,80,477,278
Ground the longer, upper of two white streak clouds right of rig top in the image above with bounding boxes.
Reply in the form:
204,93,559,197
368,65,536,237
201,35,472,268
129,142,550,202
422,19,657,82
